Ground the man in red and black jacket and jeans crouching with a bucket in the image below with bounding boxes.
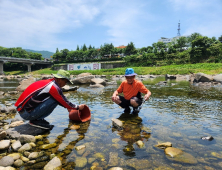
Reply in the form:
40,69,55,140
15,69,85,129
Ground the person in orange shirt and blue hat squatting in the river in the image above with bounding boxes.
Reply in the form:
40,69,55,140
112,68,151,114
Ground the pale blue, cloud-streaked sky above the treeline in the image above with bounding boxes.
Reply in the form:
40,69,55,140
0,0,222,52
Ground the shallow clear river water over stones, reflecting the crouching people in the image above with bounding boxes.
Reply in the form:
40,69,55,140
0,79,222,169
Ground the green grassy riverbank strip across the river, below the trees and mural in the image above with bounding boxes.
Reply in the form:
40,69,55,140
5,63,222,75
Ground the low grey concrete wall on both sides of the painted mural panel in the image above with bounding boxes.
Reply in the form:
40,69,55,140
53,62,125,70
